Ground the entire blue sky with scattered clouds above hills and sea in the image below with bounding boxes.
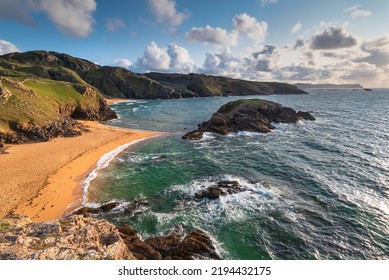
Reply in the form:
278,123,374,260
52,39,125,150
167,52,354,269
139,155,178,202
0,0,389,88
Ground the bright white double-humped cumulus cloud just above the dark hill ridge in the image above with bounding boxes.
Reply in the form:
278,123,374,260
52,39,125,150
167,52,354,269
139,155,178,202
135,42,195,73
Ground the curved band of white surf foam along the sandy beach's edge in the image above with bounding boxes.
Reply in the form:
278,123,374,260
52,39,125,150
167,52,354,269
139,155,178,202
82,136,156,205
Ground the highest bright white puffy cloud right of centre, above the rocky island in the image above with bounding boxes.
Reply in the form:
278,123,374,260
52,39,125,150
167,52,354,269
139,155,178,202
232,13,268,42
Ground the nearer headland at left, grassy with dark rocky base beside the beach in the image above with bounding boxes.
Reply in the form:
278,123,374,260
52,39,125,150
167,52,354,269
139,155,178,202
0,53,117,148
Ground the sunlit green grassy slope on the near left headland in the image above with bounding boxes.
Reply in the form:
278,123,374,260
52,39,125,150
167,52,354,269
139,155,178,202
0,65,100,132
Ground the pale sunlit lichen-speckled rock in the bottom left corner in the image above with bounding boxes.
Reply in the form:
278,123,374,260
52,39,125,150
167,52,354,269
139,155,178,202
0,215,135,260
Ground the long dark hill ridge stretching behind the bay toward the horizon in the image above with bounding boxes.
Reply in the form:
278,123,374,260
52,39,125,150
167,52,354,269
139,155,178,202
0,51,305,99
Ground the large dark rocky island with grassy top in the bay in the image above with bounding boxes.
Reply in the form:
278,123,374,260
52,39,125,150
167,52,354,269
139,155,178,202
182,99,315,140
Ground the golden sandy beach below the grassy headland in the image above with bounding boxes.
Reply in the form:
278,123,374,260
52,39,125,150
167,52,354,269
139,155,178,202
0,121,158,221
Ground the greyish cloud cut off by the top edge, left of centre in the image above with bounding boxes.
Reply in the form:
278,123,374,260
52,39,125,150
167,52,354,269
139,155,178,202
148,0,188,26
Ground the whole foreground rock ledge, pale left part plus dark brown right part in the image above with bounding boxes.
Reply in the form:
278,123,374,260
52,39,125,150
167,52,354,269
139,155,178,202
0,215,220,260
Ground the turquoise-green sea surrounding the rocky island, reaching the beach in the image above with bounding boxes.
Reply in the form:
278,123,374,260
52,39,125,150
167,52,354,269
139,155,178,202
87,90,389,259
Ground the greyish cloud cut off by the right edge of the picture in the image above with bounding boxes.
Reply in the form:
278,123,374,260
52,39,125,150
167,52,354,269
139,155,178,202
355,36,389,67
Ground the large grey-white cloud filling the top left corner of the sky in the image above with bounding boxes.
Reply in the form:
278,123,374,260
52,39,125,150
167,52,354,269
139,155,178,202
0,0,97,37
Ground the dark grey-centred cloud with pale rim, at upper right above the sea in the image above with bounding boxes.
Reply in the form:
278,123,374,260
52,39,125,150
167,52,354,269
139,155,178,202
311,26,359,50
